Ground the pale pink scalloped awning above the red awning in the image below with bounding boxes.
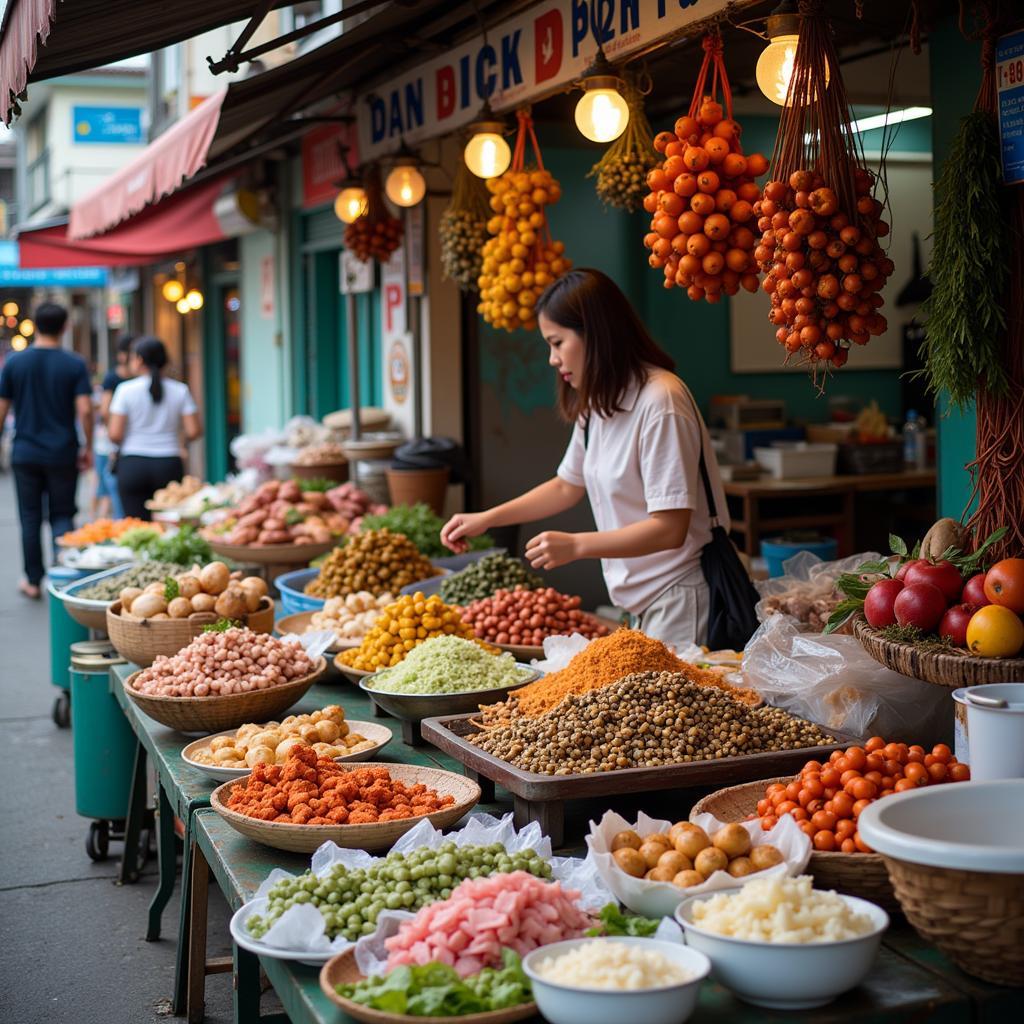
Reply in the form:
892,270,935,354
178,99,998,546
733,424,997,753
68,88,227,241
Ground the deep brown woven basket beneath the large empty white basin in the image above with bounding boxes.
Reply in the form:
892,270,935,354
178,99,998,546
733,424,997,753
882,856,1024,985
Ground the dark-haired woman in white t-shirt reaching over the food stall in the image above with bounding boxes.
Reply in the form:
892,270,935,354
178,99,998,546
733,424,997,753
441,269,729,648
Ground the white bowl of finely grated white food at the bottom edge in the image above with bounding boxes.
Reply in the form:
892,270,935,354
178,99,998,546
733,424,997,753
522,936,711,1024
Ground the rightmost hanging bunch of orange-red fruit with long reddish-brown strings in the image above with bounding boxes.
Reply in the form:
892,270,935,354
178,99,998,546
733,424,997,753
755,0,893,382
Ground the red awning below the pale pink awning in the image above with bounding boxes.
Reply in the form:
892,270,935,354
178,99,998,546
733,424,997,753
17,175,230,269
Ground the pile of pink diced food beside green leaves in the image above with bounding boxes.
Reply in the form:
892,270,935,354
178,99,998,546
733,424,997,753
385,871,593,978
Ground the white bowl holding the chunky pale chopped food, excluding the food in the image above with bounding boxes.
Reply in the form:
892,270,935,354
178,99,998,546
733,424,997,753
676,887,889,1010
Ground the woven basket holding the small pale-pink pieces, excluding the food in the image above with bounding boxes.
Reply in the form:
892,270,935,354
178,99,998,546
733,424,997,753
124,657,327,733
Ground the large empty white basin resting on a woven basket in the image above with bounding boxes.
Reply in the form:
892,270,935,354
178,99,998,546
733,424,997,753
857,778,1024,874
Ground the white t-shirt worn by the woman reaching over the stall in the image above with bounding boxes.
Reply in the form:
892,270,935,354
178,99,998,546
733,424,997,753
558,368,729,614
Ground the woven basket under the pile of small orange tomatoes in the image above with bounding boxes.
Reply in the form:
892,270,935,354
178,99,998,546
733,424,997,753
690,775,900,913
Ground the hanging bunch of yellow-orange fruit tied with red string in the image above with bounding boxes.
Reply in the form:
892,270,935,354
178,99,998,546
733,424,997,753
476,111,572,331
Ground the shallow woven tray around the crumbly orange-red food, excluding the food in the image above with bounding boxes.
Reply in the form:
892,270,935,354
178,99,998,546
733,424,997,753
210,762,480,853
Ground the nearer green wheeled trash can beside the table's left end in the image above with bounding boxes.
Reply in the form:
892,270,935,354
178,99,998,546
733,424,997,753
70,640,138,860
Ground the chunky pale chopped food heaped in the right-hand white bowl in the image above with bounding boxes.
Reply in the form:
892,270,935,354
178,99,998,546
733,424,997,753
693,874,874,943
